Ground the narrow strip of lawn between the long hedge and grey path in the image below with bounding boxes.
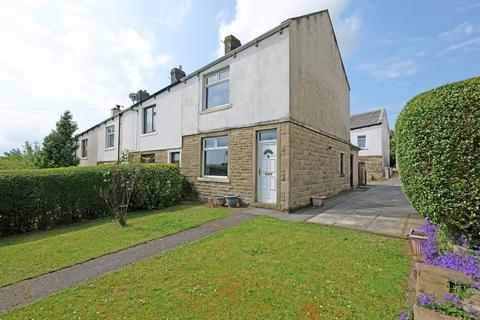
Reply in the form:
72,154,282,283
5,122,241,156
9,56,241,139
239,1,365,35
0,205,229,286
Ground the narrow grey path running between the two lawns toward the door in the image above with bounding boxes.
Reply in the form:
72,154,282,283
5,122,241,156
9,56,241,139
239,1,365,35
0,213,255,313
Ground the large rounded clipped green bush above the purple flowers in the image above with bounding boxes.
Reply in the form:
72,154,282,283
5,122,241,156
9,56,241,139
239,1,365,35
395,78,480,244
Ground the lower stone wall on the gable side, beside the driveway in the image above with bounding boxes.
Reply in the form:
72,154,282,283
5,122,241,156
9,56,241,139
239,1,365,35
289,123,358,210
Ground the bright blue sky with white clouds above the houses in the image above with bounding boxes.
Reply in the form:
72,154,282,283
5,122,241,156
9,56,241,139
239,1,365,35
0,0,480,154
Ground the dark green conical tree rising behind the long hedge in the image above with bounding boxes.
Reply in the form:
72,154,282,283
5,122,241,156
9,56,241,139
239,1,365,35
41,111,79,168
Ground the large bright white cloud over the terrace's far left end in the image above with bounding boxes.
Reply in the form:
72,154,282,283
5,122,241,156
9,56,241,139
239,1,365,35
0,0,172,153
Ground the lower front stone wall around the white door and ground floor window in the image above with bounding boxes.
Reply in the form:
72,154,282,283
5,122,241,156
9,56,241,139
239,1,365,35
182,123,288,209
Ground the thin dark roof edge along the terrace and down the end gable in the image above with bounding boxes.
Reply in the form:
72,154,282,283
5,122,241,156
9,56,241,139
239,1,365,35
76,9,350,138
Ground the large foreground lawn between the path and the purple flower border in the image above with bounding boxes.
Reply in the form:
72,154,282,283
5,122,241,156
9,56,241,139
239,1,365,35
0,217,409,320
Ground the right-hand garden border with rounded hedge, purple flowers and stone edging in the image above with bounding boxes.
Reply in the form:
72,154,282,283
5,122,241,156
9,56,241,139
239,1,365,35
395,78,480,320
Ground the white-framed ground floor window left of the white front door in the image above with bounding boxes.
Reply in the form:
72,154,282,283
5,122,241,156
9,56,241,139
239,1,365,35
202,136,228,177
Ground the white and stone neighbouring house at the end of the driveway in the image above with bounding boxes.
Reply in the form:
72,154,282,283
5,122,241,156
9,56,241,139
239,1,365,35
350,109,390,184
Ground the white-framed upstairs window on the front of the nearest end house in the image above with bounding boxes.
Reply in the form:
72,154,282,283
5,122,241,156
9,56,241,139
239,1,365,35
204,69,230,109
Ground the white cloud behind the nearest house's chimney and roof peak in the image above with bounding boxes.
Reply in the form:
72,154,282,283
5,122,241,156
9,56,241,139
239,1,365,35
216,0,362,56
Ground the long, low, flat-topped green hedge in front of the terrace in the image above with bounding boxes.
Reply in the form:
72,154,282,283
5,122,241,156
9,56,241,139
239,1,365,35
0,164,182,236
